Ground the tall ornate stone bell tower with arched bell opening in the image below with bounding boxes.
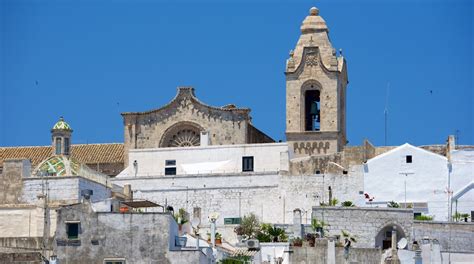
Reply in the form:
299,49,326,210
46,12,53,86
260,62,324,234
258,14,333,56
285,7,348,157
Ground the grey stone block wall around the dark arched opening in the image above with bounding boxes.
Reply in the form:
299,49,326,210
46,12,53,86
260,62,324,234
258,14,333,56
312,206,413,248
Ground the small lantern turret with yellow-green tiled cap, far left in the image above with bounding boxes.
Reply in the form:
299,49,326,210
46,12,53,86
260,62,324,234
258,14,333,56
51,116,72,156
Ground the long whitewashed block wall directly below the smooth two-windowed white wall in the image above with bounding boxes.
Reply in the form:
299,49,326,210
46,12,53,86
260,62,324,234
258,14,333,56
112,172,362,229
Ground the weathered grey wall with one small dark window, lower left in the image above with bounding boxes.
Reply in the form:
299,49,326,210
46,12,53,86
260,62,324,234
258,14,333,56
53,201,206,264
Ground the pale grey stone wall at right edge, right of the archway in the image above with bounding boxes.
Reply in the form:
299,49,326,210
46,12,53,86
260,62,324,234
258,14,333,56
413,221,474,253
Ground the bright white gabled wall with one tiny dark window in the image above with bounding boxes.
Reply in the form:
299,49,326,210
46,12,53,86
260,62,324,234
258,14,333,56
364,144,448,220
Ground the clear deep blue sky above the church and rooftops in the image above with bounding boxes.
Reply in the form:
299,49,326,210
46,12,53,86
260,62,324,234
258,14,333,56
0,0,474,146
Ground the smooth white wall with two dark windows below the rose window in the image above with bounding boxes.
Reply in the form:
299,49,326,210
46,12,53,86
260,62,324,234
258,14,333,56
117,143,288,177
